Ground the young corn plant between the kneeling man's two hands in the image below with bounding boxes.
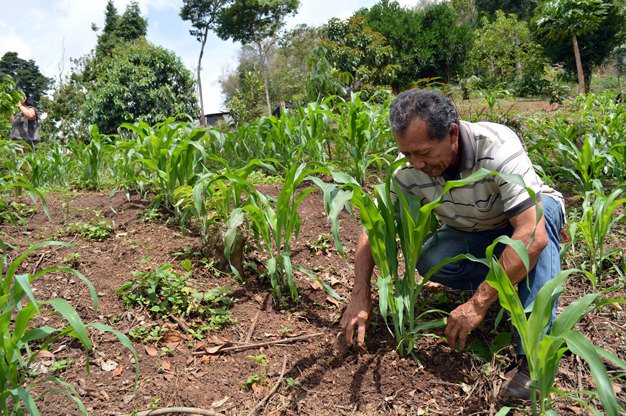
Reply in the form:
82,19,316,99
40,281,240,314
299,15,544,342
316,164,534,355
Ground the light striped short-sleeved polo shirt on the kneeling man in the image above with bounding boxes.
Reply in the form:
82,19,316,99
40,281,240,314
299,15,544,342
394,121,565,231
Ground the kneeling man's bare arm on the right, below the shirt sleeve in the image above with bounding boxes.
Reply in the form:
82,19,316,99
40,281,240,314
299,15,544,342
445,202,548,348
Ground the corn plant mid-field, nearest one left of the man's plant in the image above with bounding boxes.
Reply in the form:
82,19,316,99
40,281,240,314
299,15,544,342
224,163,339,302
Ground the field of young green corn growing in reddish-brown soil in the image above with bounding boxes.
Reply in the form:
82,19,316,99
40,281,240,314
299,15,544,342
0,93,626,415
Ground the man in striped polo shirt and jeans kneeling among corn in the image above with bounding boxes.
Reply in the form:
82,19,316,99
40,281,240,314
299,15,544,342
341,89,565,399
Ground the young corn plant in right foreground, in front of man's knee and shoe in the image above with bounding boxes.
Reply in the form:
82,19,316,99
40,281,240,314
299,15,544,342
472,236,626,416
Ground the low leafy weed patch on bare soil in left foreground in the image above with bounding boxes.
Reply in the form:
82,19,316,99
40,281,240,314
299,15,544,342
116,263,234,338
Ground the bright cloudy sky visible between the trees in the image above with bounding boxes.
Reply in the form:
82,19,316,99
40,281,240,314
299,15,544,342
0,0,419,113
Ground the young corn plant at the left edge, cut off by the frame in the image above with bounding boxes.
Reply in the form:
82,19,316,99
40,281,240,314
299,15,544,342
0,240,139,415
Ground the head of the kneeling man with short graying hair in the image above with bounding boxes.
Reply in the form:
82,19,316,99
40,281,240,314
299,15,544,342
389,89,460,176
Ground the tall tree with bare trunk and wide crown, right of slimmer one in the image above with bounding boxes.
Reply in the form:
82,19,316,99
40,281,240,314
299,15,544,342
217,0,300,114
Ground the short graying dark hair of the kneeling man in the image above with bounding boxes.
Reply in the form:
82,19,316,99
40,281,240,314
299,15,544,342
389,88,459,140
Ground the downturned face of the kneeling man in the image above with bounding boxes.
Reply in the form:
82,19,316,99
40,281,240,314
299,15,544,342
396,117,460,176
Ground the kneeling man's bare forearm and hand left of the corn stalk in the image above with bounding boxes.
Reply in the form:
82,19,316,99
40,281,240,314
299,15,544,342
341,230,374,350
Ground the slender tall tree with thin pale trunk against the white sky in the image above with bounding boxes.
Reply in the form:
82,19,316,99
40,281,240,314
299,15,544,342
180,0,229,126
